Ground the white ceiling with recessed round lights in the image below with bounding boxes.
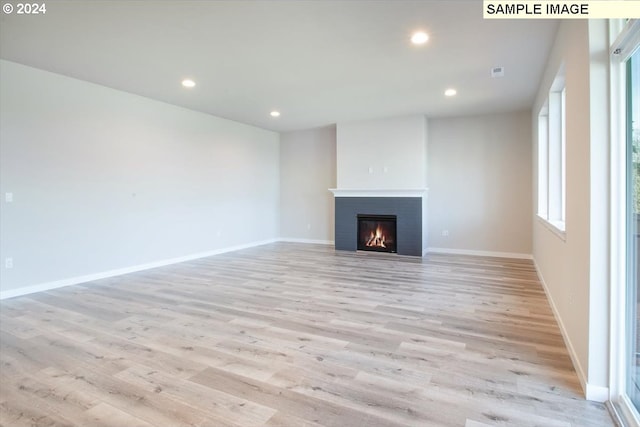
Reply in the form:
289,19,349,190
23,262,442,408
0,0,557,131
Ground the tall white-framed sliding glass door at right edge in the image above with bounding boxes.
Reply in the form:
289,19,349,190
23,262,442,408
610,20,640,425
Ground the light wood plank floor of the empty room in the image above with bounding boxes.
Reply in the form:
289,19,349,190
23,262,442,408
0,243,613,427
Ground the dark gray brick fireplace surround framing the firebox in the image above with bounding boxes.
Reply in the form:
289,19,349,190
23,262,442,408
335,197,422,256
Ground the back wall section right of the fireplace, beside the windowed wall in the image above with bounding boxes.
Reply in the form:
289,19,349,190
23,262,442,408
428,112,532,256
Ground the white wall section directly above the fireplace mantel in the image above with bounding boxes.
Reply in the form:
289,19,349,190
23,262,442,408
337,116,427,190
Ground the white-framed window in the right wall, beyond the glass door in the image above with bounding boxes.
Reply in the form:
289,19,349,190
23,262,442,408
538,67,566,238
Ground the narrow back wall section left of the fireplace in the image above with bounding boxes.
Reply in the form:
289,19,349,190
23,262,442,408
280,126,336,242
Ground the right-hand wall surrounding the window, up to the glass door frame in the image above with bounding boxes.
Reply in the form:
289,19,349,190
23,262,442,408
532,20,609,400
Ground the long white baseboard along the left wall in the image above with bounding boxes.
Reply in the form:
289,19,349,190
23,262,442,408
0,239,280,300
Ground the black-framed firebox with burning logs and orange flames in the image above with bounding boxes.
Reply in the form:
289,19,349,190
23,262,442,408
357,215,397,253
